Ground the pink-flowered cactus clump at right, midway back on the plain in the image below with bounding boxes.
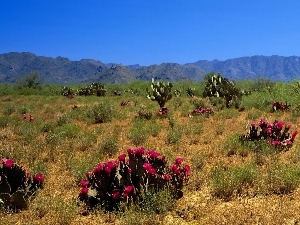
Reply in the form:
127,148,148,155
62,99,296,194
241,118,298,150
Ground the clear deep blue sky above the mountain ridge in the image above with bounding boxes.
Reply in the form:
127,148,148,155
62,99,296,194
0,0,300,65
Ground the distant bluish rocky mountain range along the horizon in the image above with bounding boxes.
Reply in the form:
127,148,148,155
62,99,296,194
0,52,300,84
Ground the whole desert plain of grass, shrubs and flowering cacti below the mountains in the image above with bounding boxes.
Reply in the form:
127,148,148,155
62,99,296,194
0,73,300,225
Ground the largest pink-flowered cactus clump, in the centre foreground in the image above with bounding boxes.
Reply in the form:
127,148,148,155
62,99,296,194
79,147,190,211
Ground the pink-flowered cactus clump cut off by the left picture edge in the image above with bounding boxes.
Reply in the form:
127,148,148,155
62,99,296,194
0,158,44,209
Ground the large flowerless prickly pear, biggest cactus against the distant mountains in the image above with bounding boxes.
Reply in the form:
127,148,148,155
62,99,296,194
203,73,242,108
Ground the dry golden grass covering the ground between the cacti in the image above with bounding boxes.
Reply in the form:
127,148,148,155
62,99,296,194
0,96,300,225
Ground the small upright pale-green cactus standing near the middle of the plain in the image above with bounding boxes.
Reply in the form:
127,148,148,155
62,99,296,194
147,78,173,108
